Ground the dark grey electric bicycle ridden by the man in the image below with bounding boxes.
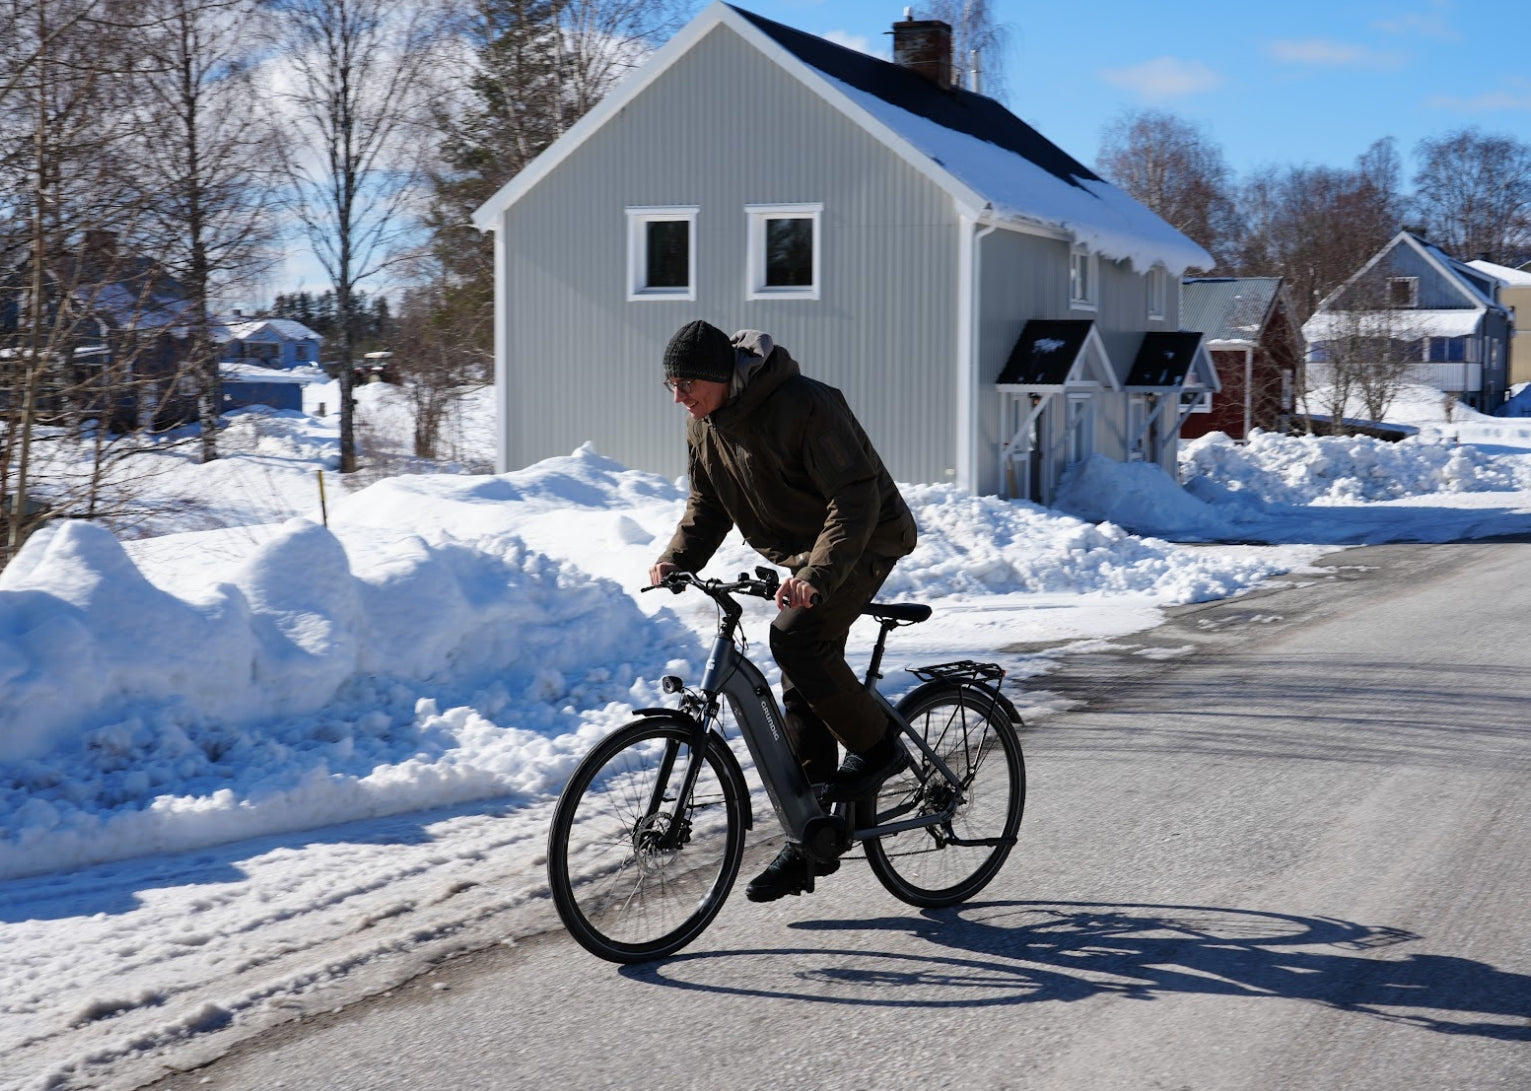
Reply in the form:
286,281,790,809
548,568,1026,962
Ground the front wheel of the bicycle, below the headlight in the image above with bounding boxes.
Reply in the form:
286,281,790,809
548,716,744,962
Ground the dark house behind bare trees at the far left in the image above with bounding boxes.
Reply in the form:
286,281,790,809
0,231,196,430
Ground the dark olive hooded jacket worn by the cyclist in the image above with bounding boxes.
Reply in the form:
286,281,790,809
660,331,916,595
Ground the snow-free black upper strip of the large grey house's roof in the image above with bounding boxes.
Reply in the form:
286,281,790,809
729,5,1101,185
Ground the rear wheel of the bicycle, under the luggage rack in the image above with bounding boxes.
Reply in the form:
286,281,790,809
867,686,1026,907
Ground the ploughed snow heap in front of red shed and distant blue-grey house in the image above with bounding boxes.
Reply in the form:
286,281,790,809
1180,432,1519,506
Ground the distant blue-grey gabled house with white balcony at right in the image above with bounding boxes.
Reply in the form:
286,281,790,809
1303,231,1511,412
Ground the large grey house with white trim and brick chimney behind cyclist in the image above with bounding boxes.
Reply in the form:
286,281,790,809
475,3,1217,502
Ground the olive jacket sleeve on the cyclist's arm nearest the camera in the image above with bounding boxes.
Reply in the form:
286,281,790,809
796,402,882,595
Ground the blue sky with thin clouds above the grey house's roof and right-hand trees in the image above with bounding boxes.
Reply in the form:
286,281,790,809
736,0,1531,187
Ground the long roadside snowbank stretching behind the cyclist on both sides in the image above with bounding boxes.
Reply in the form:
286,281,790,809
0,447,1304,877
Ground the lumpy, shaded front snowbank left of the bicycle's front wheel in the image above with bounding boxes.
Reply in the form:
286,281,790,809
0,508,698,877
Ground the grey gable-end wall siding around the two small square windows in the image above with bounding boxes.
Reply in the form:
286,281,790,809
499,26,958,480
